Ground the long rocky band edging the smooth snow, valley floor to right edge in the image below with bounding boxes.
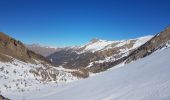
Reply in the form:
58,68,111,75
86,27,170,73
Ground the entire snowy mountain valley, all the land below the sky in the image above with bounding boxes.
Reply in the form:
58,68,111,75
0,27,170,100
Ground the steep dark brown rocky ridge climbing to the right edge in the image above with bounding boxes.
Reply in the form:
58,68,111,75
126,27,170,63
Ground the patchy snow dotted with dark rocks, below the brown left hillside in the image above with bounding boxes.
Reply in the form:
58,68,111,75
0,58,77,98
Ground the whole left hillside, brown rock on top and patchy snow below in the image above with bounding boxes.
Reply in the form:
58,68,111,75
0,33,80,94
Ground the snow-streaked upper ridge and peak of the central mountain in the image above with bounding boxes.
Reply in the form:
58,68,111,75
78,35,153,53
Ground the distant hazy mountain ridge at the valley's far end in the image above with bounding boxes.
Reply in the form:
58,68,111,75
26,44,62,57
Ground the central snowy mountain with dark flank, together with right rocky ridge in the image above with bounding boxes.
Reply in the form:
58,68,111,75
47,27,170,73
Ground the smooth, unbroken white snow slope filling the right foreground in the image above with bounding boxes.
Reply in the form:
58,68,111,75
2,49,170,100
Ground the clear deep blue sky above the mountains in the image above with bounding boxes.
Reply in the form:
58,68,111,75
0,0,170,46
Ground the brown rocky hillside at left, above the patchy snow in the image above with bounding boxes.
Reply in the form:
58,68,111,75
0,32,50,63
